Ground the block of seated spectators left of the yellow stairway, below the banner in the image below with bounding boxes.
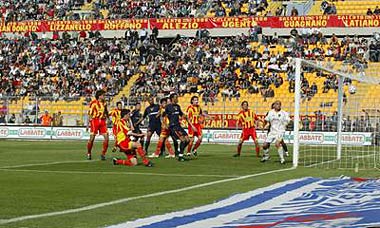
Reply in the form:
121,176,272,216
0,30,137,101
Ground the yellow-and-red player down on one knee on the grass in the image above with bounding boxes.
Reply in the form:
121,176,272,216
112,109,153,167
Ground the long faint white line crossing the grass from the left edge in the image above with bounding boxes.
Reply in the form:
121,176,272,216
0,168,240,178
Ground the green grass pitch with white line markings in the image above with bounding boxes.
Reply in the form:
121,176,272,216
0,140,380,228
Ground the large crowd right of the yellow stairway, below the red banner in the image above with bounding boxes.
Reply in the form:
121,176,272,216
127,30,368,102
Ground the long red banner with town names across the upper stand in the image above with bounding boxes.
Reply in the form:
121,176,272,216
0,15,380,33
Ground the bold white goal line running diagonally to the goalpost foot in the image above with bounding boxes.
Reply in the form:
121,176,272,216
0,167,294,225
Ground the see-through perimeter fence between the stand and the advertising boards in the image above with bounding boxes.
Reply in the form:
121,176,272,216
0,94,380,132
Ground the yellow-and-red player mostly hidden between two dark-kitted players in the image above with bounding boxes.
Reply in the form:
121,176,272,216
149,98,175,158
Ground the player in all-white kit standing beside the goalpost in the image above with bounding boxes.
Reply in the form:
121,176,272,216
261,101,290,164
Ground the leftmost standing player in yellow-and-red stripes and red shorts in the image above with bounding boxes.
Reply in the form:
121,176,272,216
87,90,109,161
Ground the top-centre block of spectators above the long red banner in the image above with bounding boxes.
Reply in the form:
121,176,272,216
94,0,268,19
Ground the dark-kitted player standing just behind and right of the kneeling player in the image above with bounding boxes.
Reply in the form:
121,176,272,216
143,97,161,153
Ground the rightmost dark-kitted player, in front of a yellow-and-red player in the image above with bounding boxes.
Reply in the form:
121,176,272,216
165,94,196,161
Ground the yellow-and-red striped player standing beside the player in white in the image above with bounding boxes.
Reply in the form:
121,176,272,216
234,101,260,157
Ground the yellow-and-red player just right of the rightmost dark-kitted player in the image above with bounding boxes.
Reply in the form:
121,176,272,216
186,96,204,156
